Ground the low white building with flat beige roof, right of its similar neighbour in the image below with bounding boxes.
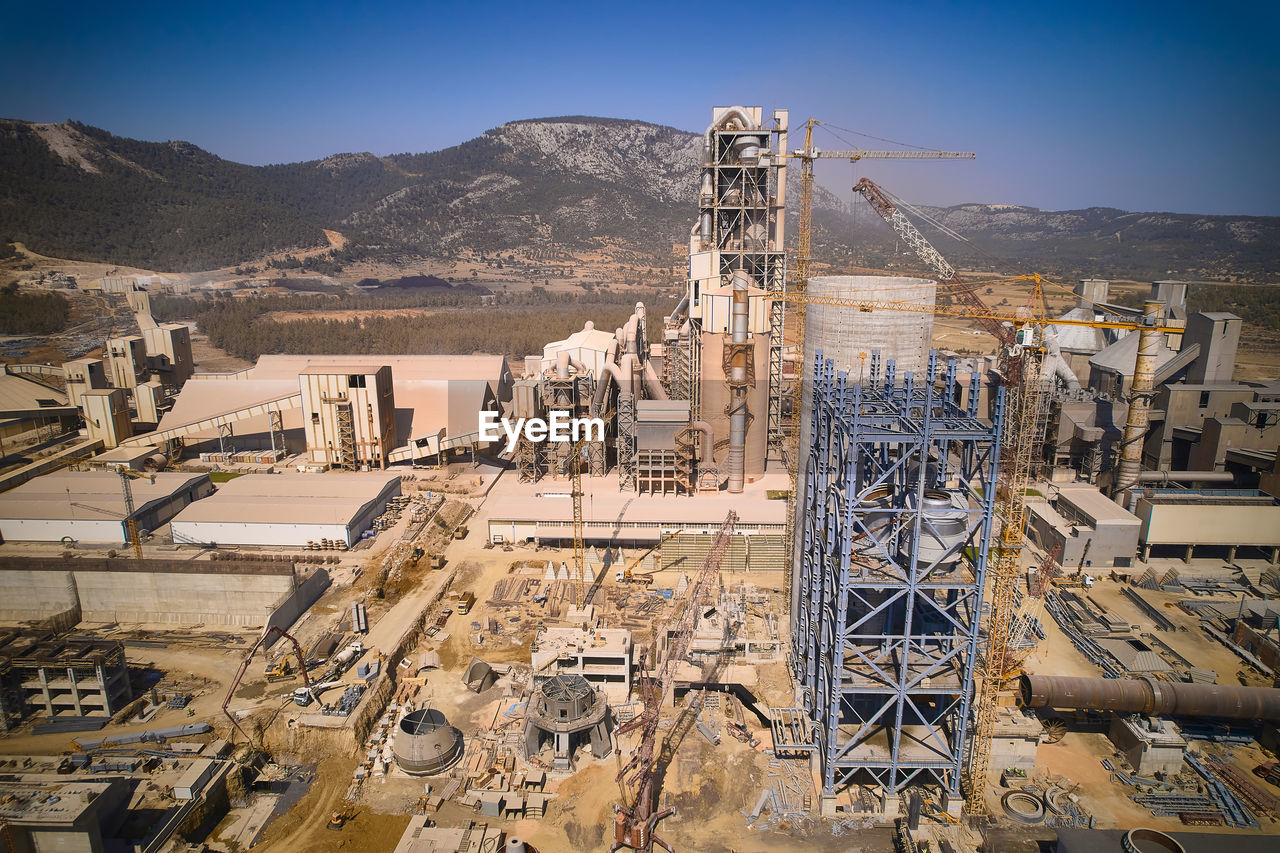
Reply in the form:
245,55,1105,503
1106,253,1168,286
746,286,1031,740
170,471,401,547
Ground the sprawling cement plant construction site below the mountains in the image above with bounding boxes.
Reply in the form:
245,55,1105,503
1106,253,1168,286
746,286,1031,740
0,106,1280,853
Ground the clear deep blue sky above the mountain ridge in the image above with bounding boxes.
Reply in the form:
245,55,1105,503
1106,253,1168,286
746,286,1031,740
0,0,1280,215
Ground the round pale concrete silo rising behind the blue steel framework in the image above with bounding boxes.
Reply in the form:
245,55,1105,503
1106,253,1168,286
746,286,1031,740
791,275,937,613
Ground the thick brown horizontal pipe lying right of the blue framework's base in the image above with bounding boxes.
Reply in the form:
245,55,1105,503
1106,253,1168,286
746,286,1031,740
1020,675,1280,722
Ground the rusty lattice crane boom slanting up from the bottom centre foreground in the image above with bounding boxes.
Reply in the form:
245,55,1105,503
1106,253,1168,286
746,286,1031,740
609,511,737,853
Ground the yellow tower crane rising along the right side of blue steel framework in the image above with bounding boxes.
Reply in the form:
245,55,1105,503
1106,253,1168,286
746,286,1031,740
783,178,1181,813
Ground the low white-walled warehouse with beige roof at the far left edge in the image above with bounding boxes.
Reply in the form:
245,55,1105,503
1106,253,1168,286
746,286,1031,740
0,471,214,543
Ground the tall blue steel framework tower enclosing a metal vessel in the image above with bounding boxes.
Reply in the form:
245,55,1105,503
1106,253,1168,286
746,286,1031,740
792,351,1005,797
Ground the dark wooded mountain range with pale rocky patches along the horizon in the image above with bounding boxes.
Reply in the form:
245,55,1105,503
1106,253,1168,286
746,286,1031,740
0,117,1280,278
